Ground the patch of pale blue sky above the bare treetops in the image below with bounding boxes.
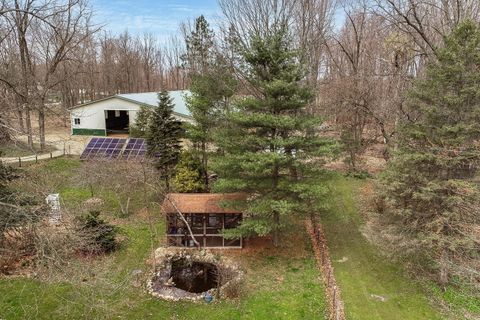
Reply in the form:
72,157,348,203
91,0,220,41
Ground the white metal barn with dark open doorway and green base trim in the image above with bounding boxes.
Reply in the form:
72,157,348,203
70,90,192,136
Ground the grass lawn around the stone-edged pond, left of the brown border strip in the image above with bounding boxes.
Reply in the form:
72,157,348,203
0,158,325,320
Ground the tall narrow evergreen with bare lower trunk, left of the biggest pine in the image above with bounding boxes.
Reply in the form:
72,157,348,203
183,15,236,190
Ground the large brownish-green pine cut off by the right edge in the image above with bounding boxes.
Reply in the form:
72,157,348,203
381,22,480,284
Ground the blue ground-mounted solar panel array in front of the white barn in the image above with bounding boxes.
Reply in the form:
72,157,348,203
80,138,147,160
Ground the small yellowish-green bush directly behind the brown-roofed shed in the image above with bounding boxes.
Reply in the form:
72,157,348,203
172,151,204,193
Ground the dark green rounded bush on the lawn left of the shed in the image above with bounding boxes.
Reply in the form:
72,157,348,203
78,211,118,254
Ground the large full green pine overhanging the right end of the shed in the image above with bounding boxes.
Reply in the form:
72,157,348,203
213,27,332,246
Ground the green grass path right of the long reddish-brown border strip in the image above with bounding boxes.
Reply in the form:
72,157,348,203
321,175,442,320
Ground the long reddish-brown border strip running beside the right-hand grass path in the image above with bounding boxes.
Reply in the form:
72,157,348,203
305,217,346,320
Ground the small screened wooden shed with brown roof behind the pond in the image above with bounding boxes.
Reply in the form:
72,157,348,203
162,193,245,248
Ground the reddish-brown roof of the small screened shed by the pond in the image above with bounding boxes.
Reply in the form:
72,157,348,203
162,193,246,213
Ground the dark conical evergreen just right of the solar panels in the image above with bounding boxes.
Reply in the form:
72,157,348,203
147,91,184,190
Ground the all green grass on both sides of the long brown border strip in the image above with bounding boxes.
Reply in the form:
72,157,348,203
5,157,474,320
